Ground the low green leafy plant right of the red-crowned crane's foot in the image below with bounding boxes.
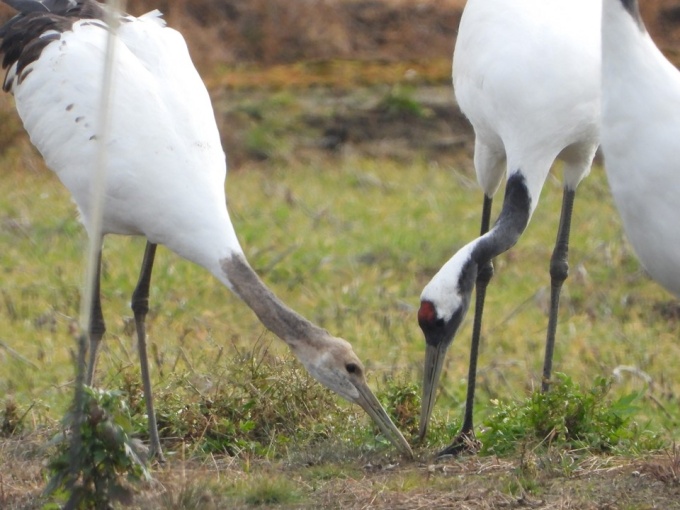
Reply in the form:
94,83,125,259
480,374,660,455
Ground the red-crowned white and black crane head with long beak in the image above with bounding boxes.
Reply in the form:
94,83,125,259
418,256,477,440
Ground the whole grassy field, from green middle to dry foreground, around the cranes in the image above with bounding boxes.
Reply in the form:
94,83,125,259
0,78,680,508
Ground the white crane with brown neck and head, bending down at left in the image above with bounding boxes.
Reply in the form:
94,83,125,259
0,0,412,459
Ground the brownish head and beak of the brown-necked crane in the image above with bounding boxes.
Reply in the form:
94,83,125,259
291,331,413,457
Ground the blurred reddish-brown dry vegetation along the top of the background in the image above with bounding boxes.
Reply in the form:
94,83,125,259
129,0,680,69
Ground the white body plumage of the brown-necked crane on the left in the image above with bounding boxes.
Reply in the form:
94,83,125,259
10,14,242,274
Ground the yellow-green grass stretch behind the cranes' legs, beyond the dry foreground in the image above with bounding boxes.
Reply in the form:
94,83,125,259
0,140,680,446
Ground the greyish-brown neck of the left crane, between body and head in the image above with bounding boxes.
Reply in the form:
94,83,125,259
220,254,325,347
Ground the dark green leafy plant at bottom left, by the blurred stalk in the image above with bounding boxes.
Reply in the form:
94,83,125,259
45,387,150,510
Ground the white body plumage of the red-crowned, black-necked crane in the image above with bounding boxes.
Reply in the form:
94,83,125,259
453,0,600,202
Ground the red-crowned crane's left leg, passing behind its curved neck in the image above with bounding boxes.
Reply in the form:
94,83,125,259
437,195,493,457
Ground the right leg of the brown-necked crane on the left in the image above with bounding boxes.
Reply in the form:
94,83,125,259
131,242,165,462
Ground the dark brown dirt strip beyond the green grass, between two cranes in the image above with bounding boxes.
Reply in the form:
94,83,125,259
214,83,473,170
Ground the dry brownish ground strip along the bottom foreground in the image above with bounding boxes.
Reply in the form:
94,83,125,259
0,437,680,510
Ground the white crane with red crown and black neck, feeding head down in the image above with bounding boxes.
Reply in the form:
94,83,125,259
418,0,601,455
